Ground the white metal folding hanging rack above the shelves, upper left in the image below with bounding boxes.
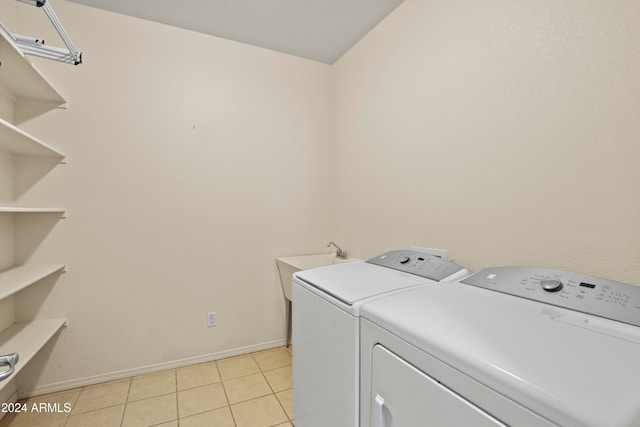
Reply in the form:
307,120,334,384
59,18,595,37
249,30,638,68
0,0,82,65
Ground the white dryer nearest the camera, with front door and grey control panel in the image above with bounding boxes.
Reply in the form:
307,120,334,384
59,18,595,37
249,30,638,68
361,267,640,427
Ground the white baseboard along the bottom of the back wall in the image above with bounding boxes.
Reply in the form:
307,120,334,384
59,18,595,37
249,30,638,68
18,340,286,399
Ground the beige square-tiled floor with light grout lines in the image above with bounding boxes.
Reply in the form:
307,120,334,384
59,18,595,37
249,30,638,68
0,347,293,427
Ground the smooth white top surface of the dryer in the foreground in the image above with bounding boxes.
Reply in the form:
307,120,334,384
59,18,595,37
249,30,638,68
362,283,640,427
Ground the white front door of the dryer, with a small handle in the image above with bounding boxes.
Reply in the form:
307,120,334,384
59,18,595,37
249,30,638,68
370,345,506,427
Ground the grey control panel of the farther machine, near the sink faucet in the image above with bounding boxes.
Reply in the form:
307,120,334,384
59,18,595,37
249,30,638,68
367,250,468,282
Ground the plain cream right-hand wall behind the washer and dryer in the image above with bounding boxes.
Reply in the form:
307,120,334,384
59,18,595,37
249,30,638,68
333,0,640,284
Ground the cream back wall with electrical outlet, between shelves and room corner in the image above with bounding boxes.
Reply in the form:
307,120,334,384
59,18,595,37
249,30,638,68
13,1,332,392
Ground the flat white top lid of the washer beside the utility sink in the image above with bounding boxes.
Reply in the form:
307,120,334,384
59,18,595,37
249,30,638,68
294,262,437,306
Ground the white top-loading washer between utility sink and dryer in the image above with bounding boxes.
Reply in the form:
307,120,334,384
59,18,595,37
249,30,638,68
292,250,468,427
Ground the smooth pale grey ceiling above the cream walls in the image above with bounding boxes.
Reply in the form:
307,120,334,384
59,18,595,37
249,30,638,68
70,0,403,64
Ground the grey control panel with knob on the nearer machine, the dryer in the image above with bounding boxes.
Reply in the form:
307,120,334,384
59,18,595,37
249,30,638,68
461,267,640,326
